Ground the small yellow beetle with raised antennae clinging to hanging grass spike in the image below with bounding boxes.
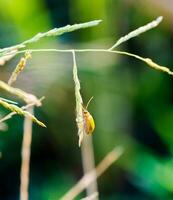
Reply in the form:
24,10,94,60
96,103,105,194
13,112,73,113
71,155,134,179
83,97,95,135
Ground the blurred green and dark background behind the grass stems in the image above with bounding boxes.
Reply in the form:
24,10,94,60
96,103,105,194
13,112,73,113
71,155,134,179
0,0,173,200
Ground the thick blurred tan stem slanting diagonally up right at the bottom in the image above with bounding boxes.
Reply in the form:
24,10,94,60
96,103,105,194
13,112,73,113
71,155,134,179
61,147,123,200
